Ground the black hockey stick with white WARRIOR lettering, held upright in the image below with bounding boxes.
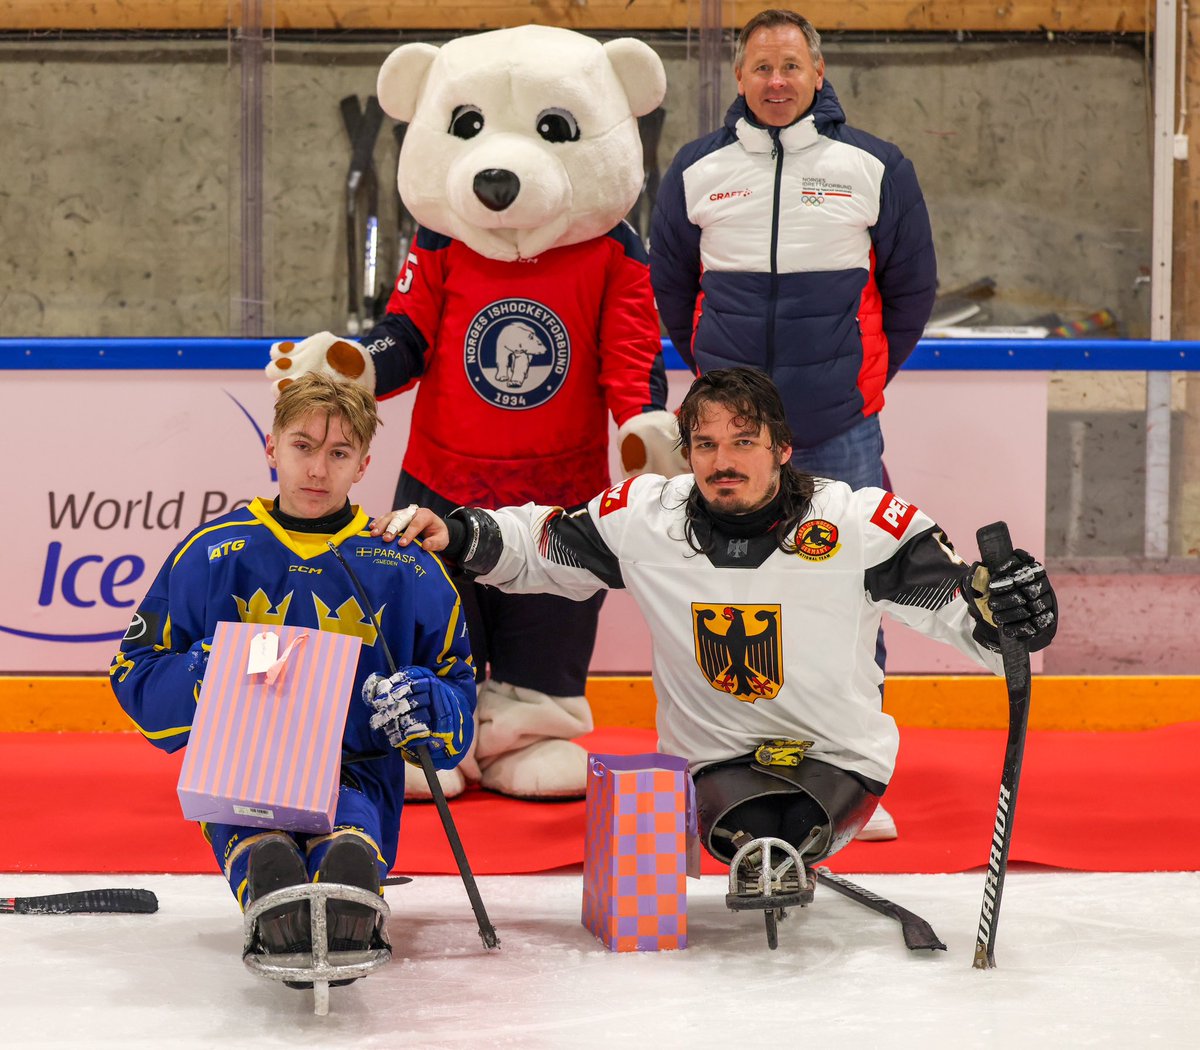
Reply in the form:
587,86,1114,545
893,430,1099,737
971,521,1030,970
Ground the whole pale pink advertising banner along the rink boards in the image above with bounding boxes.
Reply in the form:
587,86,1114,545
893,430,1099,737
0,357,1046,674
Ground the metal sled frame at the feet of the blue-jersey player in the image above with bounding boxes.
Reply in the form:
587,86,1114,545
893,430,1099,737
242,882,391,1016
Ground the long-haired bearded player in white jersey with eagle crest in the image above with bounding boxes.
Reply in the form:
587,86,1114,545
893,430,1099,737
374,368,1057,892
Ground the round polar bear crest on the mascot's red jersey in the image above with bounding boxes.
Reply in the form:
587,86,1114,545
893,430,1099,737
463,299,571,412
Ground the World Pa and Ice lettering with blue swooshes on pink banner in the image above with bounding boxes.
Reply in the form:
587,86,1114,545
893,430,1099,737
0,391,276,643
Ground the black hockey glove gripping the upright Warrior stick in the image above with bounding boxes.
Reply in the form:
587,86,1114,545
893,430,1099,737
962,551,1058,653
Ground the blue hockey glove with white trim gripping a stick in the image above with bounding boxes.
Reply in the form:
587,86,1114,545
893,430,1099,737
362,667,469,769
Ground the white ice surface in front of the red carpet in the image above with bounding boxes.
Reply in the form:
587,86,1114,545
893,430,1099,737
0,870,1200,1050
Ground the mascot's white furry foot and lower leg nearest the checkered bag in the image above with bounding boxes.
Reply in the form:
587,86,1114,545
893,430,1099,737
475,682,593,798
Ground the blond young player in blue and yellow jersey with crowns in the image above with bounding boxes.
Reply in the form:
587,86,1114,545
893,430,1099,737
109,373,475,986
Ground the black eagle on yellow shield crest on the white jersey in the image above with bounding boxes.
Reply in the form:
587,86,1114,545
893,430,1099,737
691,602,784,703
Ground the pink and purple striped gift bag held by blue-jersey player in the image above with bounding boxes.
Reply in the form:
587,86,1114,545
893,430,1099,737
178,623,362,832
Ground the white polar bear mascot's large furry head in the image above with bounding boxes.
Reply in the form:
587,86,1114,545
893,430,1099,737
378,25,666,262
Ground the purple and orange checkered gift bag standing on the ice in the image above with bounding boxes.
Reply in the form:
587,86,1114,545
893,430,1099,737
582,752,700,952
